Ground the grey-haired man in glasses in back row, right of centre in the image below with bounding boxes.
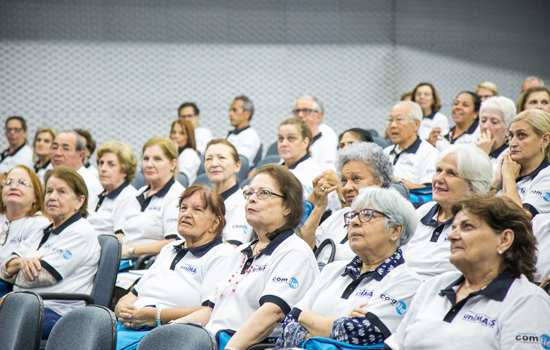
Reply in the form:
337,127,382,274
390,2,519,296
292,96,338,169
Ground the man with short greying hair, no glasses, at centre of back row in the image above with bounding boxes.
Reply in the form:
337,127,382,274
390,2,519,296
226,95,262,168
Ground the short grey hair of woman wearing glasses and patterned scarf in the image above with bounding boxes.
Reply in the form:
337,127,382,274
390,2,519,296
351,187,418,246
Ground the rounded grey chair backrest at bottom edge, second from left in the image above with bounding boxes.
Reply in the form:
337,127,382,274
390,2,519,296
46,305,116,350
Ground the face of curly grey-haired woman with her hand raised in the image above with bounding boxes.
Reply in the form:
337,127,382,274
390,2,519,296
340,160,382,206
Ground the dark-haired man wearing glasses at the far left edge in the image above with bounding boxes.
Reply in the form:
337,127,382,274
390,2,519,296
0,116,33,173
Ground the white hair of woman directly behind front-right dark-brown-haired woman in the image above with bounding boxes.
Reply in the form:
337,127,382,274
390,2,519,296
437,144,493,194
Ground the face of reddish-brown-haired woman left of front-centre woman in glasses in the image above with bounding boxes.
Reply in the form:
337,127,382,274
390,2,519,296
178,191,218,242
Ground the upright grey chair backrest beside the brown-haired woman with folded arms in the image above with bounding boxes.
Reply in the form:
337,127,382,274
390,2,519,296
91,235,120,307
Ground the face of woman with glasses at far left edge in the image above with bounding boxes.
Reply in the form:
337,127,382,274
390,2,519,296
2,168,35,213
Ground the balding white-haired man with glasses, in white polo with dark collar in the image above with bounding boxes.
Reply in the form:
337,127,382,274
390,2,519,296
384,101,439,189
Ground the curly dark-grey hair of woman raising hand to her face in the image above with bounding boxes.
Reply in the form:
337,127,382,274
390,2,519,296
337,142,393,187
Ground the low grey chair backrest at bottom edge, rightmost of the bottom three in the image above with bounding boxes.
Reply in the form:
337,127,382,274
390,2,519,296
137,324,215,350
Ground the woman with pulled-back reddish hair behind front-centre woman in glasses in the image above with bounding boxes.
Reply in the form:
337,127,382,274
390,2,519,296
204,139,252,245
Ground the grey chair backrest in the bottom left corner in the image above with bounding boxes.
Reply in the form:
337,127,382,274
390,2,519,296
0,291,44,350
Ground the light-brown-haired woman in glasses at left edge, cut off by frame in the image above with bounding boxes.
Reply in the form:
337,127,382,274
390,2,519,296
0,165,49,295
